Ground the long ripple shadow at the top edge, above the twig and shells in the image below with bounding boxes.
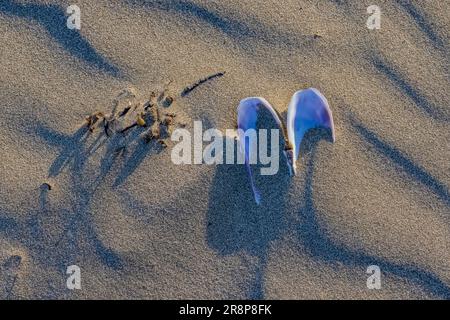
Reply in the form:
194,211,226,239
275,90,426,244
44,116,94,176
125,0,312,47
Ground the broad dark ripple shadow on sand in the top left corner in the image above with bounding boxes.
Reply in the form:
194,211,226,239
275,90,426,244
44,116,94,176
0,0,122,77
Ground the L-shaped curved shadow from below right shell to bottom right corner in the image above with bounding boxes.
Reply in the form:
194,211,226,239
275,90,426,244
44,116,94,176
298,136,450,299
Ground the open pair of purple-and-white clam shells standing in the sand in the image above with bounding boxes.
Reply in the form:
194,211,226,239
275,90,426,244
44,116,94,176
237,88,335,205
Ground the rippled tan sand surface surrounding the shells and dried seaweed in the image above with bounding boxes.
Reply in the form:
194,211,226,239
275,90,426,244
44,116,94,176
0,0,450,299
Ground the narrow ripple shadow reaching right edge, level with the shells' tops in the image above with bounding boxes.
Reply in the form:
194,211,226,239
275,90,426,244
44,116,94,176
372,57,450,122
